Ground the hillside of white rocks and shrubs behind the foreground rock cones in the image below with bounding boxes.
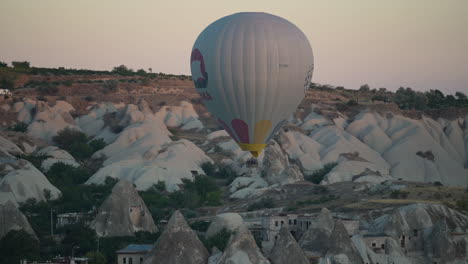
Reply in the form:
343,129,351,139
0,65,468,259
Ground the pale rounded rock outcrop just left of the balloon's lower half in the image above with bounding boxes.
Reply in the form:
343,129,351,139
156,101,203,130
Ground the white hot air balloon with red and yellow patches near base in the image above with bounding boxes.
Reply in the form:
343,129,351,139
190,12,314,157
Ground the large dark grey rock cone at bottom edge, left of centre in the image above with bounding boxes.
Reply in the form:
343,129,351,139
143,211,209,264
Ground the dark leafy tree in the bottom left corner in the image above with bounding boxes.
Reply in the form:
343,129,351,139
0,230,39,264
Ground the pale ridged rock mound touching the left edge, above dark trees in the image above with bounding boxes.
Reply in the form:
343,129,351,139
0,159,61,203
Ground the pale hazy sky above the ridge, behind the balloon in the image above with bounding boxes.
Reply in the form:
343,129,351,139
0,0,468,93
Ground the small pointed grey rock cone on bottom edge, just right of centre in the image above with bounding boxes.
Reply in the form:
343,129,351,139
269,227,309,264
